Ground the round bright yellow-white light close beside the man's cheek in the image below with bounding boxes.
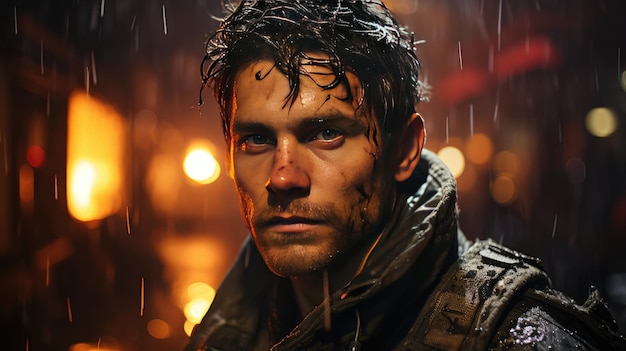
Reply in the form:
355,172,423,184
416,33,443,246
183,141,221,184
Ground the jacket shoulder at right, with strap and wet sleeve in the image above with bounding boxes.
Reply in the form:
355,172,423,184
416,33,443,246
401,240,624,350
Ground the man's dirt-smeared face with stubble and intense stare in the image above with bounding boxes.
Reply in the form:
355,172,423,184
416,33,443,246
229,56,393,277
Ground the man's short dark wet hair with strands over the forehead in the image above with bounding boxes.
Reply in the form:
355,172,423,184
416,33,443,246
200,0,424,145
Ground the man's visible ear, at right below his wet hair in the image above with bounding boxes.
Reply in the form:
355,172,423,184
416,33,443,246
395,113,426,182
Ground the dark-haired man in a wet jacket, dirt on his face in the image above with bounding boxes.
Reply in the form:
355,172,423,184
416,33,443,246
187,0,626,350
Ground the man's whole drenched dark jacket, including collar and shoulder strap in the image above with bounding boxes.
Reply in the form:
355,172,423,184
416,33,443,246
186,150,626,351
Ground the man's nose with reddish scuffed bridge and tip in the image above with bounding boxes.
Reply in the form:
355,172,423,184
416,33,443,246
265,141,311,202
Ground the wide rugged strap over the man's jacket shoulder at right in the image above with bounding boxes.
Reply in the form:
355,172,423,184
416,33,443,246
399,240,550,350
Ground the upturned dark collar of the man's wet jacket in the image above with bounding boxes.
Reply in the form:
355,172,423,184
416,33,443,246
185,150,467,351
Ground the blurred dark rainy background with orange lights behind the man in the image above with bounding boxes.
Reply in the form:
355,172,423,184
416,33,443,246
0,0,626,351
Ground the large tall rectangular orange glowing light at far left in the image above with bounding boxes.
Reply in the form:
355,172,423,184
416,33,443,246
67,91,126,222
